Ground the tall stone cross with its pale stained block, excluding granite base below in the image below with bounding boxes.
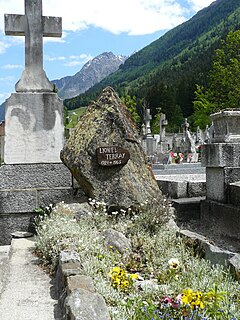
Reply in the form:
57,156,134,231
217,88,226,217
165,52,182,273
4,0,64,164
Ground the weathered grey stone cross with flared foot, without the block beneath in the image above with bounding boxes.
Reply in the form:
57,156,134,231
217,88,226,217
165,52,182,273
4,0,62,92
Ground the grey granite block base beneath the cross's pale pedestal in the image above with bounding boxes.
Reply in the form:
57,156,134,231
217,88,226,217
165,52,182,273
0,163,83,245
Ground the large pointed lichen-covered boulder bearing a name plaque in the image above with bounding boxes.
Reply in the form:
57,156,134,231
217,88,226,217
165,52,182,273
61,87,162,208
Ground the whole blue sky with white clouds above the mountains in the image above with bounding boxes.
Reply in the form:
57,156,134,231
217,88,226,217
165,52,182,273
0,0,213,104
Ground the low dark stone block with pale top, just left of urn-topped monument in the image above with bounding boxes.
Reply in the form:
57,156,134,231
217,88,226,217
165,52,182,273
172,197,205,222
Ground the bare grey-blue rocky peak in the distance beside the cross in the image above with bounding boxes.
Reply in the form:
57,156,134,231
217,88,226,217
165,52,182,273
52,52,127,99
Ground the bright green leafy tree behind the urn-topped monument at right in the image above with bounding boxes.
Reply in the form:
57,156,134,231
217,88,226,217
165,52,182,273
193,30,240,127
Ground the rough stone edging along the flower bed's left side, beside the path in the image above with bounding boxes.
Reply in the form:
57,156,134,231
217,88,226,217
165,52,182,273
56,251,110,320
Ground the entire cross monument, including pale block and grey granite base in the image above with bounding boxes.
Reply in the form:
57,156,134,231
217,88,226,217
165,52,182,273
0,0,78,244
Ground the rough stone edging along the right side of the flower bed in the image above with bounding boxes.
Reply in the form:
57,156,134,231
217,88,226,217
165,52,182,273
177,230,240,280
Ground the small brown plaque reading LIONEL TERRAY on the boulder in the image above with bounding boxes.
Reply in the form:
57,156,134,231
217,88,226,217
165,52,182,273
96,146,130,166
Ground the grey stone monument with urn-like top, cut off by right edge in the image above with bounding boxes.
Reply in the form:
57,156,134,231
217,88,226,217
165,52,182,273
201,110,240,241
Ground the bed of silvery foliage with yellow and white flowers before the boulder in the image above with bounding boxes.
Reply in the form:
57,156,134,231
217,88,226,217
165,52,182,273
35,200,240,320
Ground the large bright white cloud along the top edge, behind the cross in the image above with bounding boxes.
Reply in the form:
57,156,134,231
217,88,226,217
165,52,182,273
0,0,212,35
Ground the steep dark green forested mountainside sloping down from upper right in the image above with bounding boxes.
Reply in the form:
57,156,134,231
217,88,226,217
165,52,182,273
65,0,240,130
